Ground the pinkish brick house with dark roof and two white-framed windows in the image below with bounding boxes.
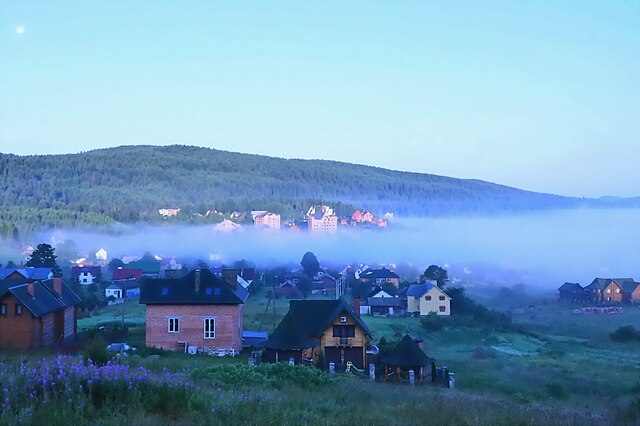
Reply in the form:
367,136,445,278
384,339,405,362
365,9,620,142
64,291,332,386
140,269,248,352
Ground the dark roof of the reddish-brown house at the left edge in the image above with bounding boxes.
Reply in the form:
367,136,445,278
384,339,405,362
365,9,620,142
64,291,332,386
0,279,80,318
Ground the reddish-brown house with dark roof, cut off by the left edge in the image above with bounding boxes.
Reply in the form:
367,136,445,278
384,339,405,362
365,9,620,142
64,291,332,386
0,277,80,351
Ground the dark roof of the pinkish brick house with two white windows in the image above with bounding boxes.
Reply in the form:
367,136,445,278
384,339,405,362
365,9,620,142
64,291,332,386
140,269,249,305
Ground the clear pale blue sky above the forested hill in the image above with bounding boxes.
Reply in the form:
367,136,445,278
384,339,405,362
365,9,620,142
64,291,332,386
0,0,640,197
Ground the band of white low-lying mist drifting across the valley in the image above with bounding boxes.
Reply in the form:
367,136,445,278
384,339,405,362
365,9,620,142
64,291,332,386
6,209,640,288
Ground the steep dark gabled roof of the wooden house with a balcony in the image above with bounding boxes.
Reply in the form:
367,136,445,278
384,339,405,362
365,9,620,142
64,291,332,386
265,299,371,349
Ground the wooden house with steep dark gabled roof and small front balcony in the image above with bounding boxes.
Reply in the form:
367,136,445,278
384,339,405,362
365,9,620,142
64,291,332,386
265,299,371,371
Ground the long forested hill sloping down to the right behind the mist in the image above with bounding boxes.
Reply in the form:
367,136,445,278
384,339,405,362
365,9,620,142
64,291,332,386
0,146,632,235
